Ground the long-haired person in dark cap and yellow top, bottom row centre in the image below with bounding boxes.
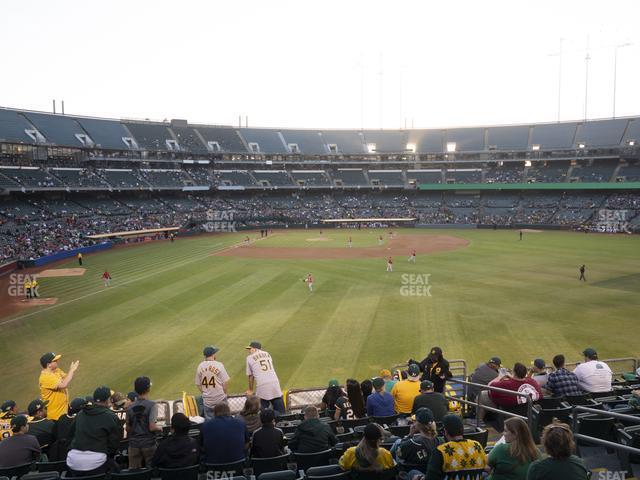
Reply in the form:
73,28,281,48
339,423,395,472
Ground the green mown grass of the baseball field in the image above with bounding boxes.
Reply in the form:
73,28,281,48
0,229,640,408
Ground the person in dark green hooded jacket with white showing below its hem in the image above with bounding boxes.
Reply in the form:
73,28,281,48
67,386,122,476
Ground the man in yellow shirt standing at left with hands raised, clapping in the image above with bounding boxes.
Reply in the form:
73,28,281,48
38,352,79,420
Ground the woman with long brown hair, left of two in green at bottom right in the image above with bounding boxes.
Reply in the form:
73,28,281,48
485,417,540,480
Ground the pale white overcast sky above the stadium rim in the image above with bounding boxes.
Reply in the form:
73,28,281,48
0,0,640,129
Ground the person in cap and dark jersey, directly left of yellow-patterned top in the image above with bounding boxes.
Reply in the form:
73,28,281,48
391,407,442,479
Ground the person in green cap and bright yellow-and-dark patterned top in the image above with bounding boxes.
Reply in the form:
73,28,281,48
425,414,487,480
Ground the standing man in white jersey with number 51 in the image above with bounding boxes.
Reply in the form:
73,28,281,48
245,341,285,414
